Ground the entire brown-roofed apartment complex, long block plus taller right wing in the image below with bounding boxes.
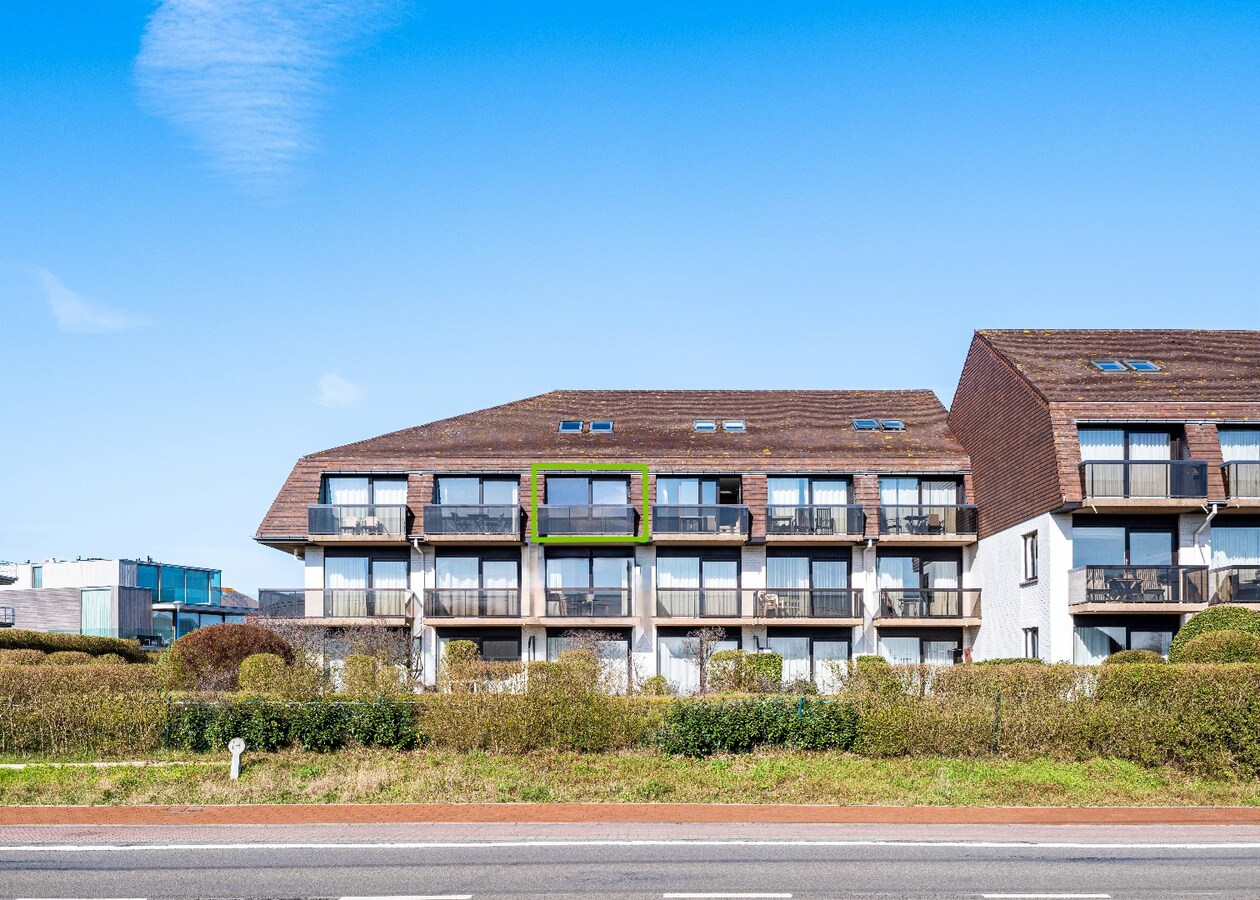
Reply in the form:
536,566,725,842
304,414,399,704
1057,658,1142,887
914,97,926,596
257,330,1260,689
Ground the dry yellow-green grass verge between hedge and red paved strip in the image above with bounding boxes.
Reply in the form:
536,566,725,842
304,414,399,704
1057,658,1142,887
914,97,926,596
7,750,1260,805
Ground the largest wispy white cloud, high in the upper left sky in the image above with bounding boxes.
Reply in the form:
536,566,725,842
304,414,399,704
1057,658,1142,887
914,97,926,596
136,0,397,189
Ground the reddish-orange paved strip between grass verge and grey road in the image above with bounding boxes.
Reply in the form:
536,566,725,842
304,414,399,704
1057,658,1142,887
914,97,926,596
0,803,1260,826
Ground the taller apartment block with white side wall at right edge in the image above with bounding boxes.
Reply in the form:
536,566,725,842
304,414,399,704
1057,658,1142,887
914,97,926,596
949,330,1260,663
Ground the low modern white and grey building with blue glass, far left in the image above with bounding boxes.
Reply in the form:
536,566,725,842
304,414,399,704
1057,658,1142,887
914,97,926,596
0,558,257,648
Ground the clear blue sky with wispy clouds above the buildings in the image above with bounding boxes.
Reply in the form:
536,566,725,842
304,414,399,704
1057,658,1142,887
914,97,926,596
0,0,1260,592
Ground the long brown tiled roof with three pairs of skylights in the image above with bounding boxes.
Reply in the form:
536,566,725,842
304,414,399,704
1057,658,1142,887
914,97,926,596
258,391,969,537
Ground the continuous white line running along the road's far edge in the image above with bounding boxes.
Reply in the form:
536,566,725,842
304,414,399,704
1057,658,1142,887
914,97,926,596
0,838,1260,853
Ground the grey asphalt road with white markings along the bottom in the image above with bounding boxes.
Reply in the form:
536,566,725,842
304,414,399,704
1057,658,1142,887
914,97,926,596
0,824,1260,900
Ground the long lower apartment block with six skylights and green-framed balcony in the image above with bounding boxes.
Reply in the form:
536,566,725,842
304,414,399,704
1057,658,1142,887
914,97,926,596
256,391,980,689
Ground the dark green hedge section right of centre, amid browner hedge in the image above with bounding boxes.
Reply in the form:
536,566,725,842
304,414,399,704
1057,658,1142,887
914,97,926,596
660,697,858,756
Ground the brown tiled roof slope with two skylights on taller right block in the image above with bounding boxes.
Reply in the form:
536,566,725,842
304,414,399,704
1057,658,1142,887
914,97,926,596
977,329,1260,402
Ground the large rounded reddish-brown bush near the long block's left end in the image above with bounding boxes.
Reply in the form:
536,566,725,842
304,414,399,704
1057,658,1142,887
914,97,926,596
161,623,294,691
